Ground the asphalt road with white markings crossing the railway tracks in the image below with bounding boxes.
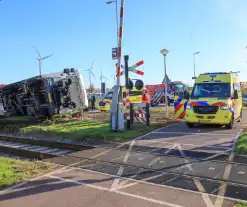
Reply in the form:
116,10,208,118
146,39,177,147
0,112,247,207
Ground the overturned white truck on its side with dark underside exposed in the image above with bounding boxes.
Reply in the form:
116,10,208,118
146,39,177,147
0,68,88,117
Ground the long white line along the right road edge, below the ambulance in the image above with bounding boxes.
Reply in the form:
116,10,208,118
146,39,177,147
215,129,243,207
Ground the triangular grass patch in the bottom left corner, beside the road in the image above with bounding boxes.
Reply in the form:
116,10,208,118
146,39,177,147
0,158,51,189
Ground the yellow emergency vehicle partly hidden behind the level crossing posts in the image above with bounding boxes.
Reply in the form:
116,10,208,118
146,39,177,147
99,87,142,111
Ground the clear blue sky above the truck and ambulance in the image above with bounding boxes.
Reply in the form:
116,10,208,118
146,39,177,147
0,0,247,87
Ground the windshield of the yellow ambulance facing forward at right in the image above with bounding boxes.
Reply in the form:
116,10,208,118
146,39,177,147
191,83,230,98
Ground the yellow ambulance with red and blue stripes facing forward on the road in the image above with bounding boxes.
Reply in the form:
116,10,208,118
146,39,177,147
184,72,242,129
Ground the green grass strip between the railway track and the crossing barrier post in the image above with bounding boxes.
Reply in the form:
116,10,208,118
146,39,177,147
21,121,164,141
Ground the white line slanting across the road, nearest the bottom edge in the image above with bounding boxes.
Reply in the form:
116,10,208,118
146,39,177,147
46,175,183,207
